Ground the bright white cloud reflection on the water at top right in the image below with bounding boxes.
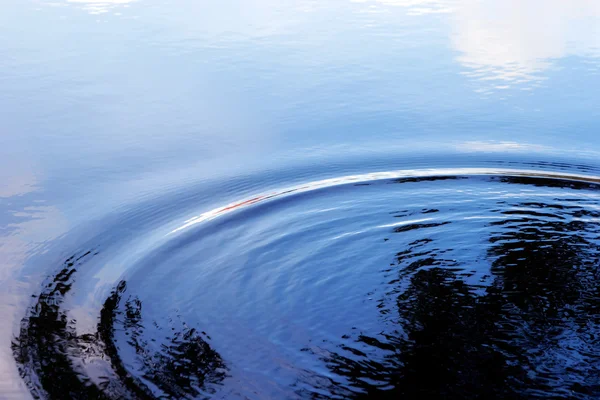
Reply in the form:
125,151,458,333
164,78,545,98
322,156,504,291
360,0,600,89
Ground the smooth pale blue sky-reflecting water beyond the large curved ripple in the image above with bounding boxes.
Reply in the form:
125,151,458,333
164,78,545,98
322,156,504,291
0,0,600,392
